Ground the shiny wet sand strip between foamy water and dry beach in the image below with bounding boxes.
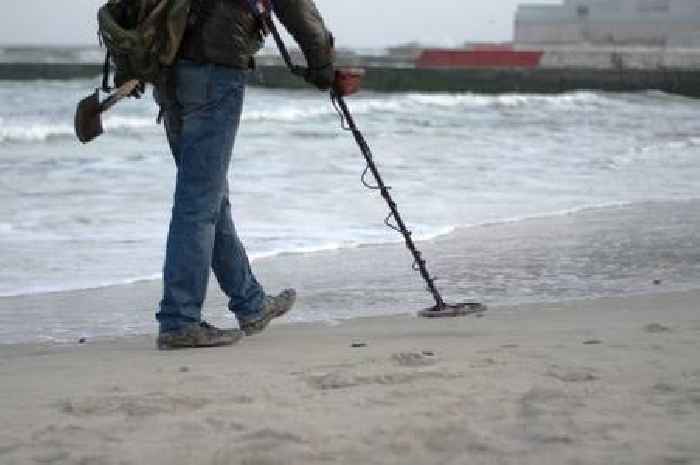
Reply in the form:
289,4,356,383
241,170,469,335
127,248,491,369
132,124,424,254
0,200,700,343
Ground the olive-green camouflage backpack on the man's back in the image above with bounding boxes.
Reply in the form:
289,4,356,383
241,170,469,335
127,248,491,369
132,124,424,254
97,0,192,92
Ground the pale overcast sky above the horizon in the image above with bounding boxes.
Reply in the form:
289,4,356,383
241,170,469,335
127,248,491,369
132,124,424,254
0,0,561,47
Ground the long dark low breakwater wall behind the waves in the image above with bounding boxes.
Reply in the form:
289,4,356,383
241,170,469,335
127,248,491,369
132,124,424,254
0,63,700,97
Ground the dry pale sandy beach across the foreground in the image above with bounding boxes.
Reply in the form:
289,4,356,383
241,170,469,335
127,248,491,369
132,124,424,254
0,291,700,465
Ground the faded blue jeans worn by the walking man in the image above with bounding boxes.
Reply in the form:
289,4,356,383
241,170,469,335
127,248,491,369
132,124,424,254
156,60,264,332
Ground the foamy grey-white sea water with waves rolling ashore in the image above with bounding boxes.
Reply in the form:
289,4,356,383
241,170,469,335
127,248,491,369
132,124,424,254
0,81,700,304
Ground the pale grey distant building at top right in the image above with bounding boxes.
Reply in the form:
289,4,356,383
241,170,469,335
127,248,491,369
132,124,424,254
515,0,700,48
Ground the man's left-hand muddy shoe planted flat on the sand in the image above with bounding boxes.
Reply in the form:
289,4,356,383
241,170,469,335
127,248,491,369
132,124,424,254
156,322,243,350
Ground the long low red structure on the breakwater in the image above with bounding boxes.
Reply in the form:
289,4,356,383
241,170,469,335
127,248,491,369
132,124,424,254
416,49,544,68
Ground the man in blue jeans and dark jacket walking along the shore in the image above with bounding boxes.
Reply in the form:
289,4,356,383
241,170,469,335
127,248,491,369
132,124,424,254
155,0,334,350
